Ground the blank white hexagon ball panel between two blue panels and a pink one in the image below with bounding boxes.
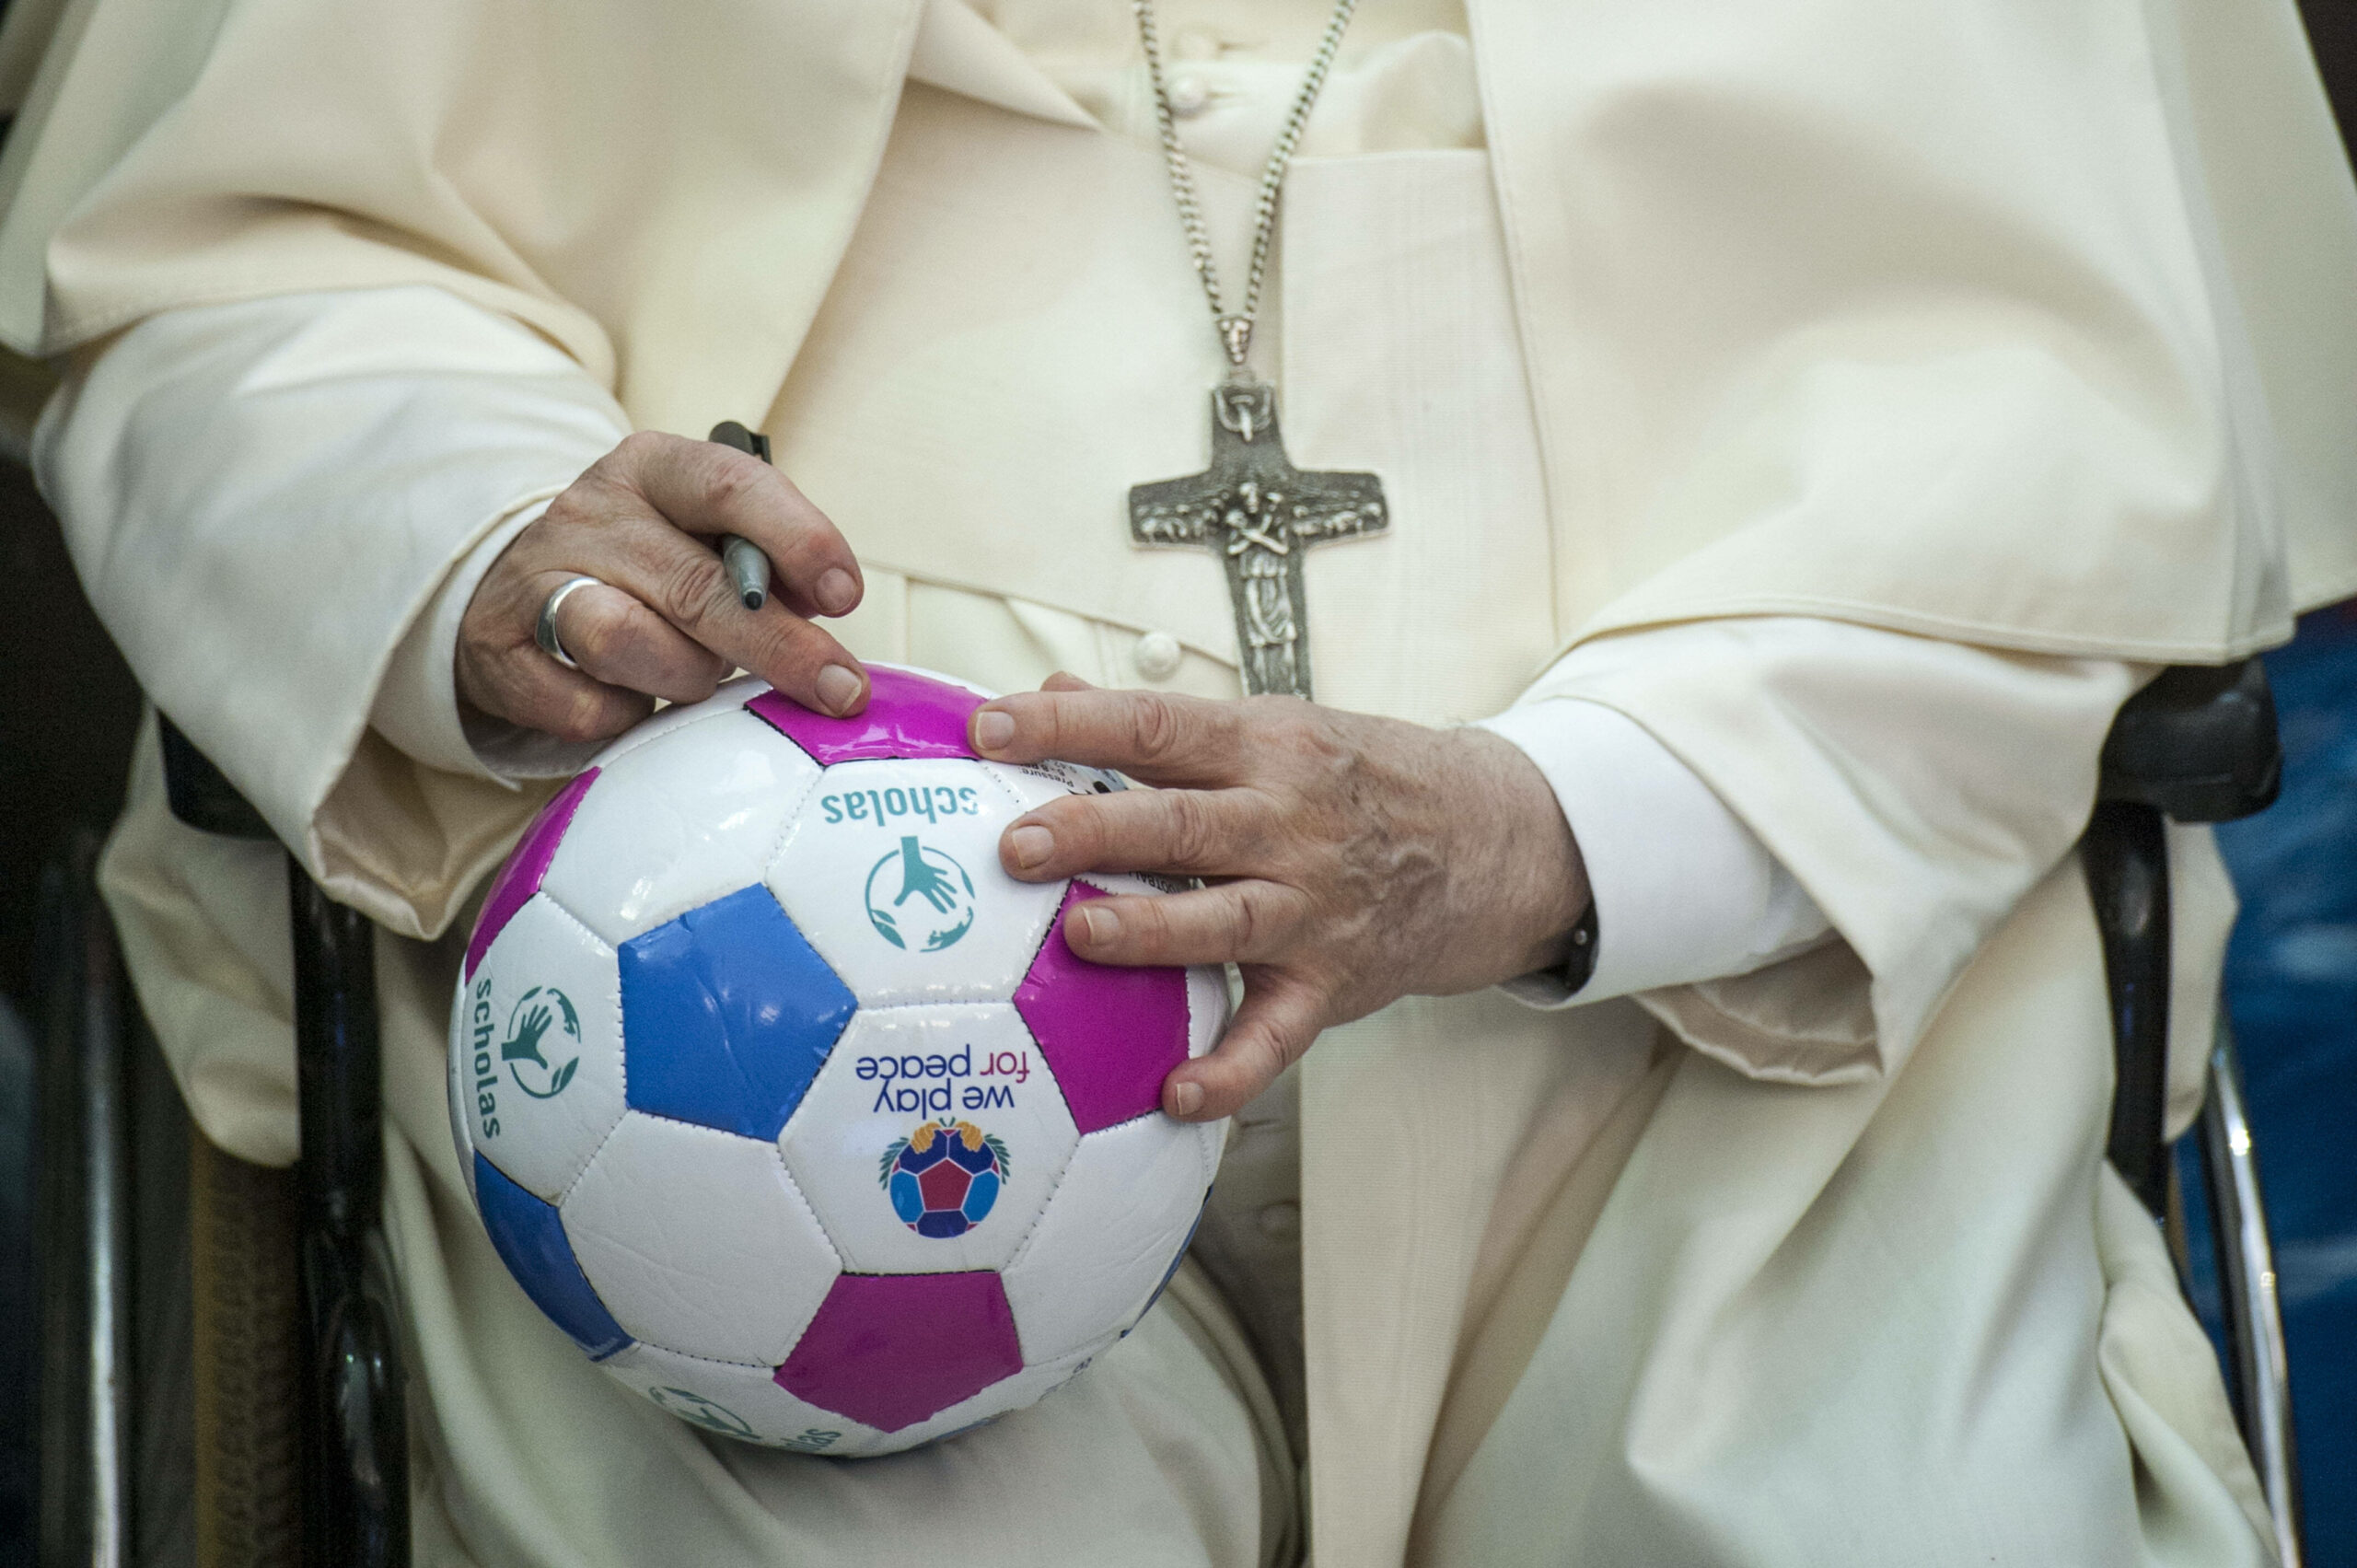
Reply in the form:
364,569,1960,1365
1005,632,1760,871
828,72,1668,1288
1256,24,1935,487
563,1110,837,1365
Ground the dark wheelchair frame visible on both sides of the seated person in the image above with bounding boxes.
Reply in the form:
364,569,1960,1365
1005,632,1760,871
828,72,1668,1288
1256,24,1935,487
42,660,2301,1568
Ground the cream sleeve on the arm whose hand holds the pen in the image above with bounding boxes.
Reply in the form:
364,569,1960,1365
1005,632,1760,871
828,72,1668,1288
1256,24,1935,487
33,287,630,936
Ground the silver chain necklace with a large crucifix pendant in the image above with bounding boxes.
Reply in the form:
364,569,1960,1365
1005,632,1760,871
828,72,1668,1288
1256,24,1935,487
1129,0,1390,698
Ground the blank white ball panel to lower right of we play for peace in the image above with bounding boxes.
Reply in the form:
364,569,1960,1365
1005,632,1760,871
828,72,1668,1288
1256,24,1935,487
1002,1113,1213,1363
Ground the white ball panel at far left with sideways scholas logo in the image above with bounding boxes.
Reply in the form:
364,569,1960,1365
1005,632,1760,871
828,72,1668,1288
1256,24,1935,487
450,894,622,1202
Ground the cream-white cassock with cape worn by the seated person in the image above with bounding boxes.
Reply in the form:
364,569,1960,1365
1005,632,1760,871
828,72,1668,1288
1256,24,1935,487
0,0,2357,1565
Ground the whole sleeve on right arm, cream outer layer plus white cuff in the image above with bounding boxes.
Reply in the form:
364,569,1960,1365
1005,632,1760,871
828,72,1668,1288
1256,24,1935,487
1487,618,2152,1082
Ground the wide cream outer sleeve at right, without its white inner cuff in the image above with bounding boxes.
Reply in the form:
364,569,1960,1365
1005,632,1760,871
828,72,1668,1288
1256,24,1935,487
1523,618,2152,1082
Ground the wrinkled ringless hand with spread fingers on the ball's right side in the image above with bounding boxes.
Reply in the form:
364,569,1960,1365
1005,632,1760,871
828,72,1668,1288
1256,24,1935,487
973,674,1588,1120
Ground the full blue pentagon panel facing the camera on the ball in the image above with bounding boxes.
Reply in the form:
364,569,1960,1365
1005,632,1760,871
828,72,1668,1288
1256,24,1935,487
620,887,858,1141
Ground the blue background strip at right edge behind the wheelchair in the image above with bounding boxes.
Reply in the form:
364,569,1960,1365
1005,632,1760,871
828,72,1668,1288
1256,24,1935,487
2180,604,2357,1568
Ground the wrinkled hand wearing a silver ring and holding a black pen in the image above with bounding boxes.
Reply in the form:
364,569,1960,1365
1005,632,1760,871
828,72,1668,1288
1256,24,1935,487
458,432,867,740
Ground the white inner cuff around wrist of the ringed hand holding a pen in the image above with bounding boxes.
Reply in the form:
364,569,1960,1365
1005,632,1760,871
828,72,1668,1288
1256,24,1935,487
367,497,606,785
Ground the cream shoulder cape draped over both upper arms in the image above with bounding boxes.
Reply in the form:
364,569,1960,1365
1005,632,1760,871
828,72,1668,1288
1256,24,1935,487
0,0,2357,660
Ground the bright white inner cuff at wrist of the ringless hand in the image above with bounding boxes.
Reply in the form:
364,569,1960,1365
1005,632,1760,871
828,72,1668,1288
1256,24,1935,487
1478,698,1831,1007
